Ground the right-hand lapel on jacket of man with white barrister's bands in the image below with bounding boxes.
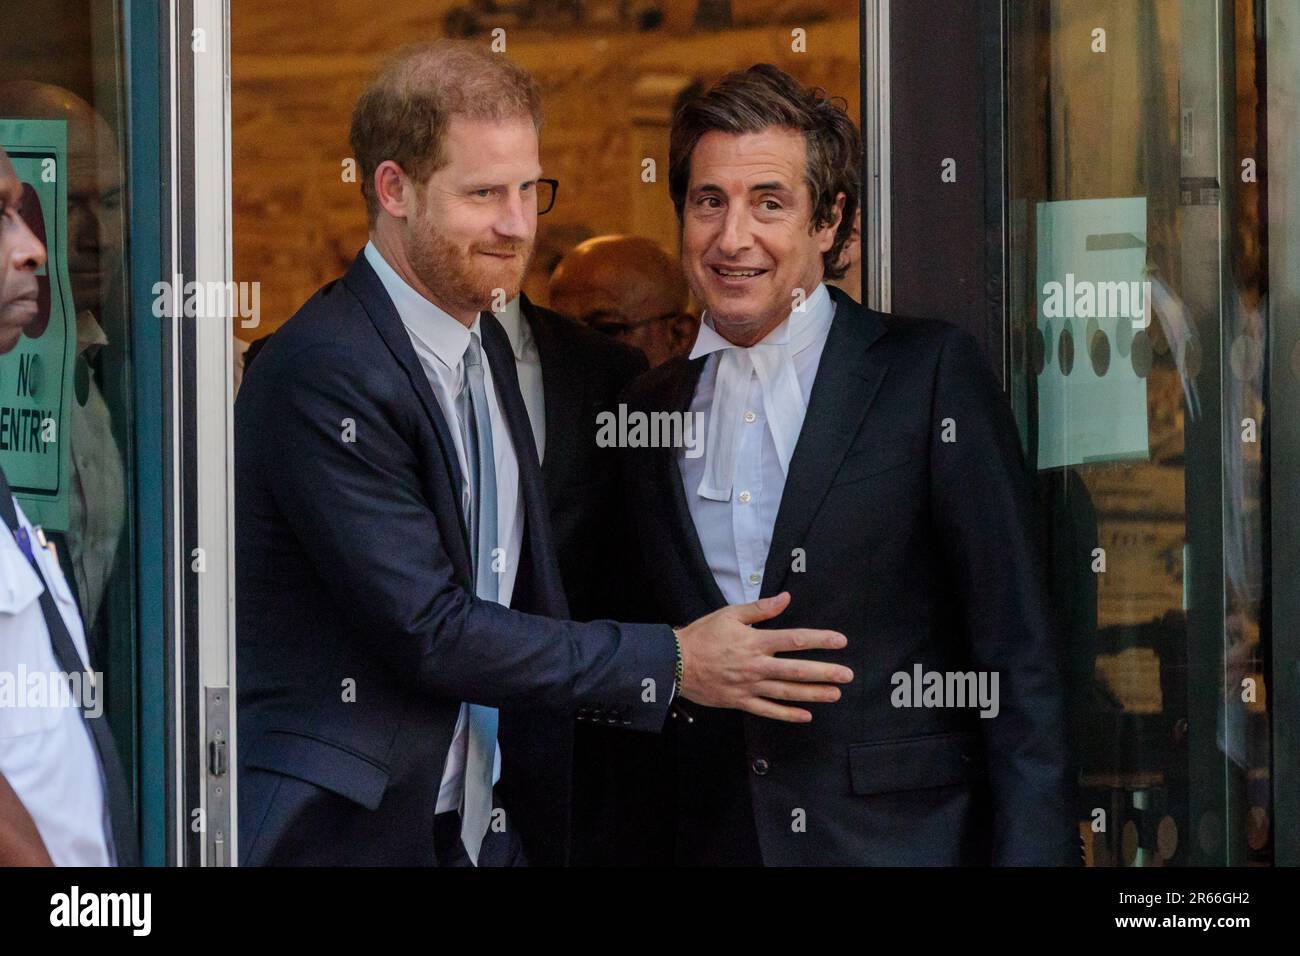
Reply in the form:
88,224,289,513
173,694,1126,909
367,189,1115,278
762,286,888,597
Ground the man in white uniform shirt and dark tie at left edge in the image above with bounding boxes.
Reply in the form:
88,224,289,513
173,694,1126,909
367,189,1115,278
0,143,139,866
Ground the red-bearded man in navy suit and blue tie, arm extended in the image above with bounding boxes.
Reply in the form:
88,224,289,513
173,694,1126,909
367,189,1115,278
235,40,852,865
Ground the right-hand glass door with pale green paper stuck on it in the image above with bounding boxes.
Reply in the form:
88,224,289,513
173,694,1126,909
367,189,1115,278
1006,0,1273,866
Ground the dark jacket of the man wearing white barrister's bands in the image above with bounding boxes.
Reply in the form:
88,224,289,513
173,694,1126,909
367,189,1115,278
624,287,1079,865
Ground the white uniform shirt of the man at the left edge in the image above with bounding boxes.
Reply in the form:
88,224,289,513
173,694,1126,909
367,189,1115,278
0,502,113,866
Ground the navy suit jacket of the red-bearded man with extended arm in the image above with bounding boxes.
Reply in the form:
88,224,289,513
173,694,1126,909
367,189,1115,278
235,255,675,865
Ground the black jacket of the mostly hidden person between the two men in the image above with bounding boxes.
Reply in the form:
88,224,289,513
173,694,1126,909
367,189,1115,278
520,295,647,620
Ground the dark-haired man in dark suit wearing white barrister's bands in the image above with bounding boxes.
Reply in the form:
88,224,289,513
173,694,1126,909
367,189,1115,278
623,65,1078,865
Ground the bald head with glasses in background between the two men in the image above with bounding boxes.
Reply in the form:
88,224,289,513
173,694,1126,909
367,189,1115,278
549,235,698,367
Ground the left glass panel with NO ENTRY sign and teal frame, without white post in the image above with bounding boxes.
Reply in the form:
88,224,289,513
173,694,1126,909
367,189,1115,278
0,0,168,862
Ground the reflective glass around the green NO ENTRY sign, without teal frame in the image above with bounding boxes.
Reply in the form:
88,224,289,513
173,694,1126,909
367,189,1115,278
0,0,135,785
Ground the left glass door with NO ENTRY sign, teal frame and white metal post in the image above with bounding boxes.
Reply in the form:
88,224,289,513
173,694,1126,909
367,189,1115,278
0,0,235,866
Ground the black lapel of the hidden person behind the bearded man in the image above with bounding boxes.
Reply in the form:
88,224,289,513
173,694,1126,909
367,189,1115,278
519,295,585,510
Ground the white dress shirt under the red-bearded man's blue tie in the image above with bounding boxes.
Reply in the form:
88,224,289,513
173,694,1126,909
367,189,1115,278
365,242,524,813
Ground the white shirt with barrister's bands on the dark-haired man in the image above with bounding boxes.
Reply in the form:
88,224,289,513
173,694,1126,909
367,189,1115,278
677,284,835,604
